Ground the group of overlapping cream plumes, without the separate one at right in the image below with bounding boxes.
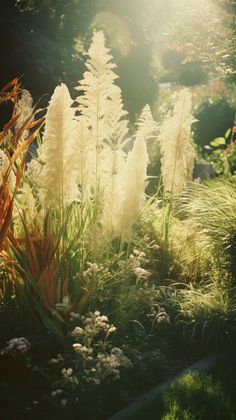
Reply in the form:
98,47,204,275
22,32,157,244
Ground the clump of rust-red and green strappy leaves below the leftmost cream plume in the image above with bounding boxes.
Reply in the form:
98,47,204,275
11,209,88,335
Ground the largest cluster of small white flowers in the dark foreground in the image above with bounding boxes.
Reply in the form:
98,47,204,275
61,311,131,386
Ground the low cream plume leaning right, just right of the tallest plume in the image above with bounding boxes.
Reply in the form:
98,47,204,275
102,105,158,237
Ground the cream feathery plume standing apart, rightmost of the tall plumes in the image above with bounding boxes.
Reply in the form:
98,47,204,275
160,89,196,197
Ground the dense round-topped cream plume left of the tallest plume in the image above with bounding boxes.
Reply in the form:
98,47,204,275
36,84,79,203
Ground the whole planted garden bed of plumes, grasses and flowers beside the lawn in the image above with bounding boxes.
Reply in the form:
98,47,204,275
0,18,236,420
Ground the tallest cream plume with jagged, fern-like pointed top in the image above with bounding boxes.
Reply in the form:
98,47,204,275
76,32,128,200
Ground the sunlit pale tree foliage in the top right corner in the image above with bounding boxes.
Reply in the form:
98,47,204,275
166,0,235,79
